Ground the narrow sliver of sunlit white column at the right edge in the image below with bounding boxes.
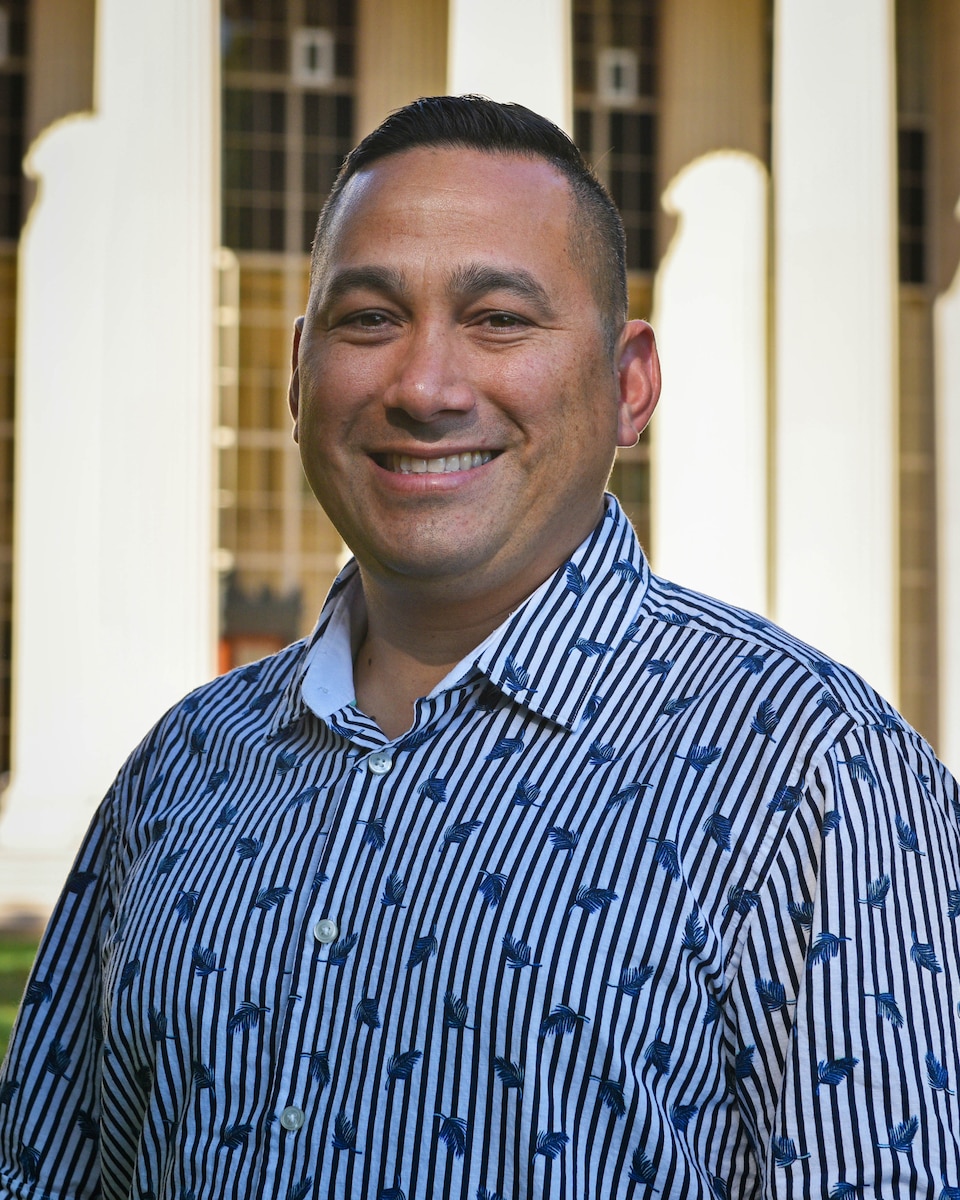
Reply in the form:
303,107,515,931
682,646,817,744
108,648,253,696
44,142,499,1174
934,204,960,774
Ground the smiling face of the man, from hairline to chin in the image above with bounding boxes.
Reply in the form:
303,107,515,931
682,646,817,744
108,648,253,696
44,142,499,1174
290,149,634,602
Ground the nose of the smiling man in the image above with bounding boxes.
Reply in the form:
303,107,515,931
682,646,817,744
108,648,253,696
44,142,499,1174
384,325,474,422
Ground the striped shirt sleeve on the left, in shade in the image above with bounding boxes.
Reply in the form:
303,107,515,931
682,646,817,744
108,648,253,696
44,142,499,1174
0,792,121,1200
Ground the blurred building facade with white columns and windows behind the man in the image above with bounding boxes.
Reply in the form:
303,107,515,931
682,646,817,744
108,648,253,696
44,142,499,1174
0,0,960,945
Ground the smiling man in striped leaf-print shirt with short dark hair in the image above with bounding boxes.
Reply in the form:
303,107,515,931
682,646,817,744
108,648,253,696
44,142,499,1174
0,97,960,1200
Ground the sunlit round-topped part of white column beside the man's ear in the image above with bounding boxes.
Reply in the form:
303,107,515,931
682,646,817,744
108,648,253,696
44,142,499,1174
652,151,767,611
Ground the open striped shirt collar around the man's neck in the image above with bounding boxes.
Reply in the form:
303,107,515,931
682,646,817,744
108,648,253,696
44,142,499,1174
271,496,649,736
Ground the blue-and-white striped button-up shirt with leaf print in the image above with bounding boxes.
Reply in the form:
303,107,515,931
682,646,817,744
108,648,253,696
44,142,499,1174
0,499,960,1200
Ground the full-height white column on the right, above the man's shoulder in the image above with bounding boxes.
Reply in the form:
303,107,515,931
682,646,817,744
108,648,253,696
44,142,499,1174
774,0,898,701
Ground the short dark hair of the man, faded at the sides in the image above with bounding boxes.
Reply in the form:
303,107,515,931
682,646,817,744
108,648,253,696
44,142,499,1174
311,96,628,346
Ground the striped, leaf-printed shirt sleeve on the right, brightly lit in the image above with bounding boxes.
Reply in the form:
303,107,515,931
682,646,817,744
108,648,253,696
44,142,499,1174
730,721,960,1200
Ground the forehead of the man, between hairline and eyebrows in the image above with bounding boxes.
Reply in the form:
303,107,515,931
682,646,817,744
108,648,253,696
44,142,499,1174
319,148,581,284
